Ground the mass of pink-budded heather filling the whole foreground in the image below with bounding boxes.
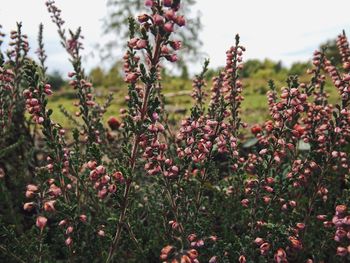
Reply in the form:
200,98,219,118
0,0,350,263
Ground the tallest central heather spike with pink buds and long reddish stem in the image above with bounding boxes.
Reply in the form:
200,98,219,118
107,0,185,262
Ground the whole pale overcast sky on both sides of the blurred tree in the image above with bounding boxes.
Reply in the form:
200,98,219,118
0,0,350,73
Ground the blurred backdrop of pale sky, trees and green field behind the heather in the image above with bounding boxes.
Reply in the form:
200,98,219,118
0,0,350,127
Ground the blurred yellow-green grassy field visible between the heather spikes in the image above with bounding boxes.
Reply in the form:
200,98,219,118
49,75,339,129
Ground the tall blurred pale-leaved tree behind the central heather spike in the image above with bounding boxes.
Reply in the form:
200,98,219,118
103,0,202,65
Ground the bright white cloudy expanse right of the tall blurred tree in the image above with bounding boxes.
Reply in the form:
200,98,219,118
198,0,350,69
